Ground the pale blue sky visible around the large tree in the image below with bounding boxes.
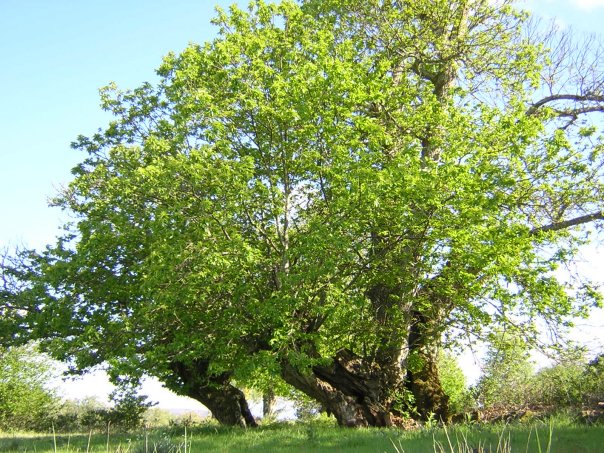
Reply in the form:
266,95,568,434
0,0,604,407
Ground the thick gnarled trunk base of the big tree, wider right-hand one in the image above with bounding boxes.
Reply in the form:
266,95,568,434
282,284,450,427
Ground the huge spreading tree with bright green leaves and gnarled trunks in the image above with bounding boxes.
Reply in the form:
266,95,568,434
4,0,604,426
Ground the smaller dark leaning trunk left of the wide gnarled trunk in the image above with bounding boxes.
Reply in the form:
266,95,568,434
167,360,257,427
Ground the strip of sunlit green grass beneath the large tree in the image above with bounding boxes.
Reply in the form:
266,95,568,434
0,420,604,453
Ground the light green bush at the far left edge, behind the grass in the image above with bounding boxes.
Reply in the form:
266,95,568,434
0,346,60,430
